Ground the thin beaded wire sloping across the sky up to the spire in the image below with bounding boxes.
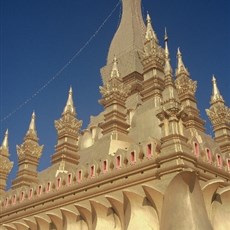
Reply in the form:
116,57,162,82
1,0,121,124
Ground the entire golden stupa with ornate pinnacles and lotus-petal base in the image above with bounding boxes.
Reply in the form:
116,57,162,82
0,0,230,230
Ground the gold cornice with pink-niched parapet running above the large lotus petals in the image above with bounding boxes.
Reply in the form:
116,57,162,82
1,140,229,225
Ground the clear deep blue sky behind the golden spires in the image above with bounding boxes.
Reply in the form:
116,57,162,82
0,0,230,189
